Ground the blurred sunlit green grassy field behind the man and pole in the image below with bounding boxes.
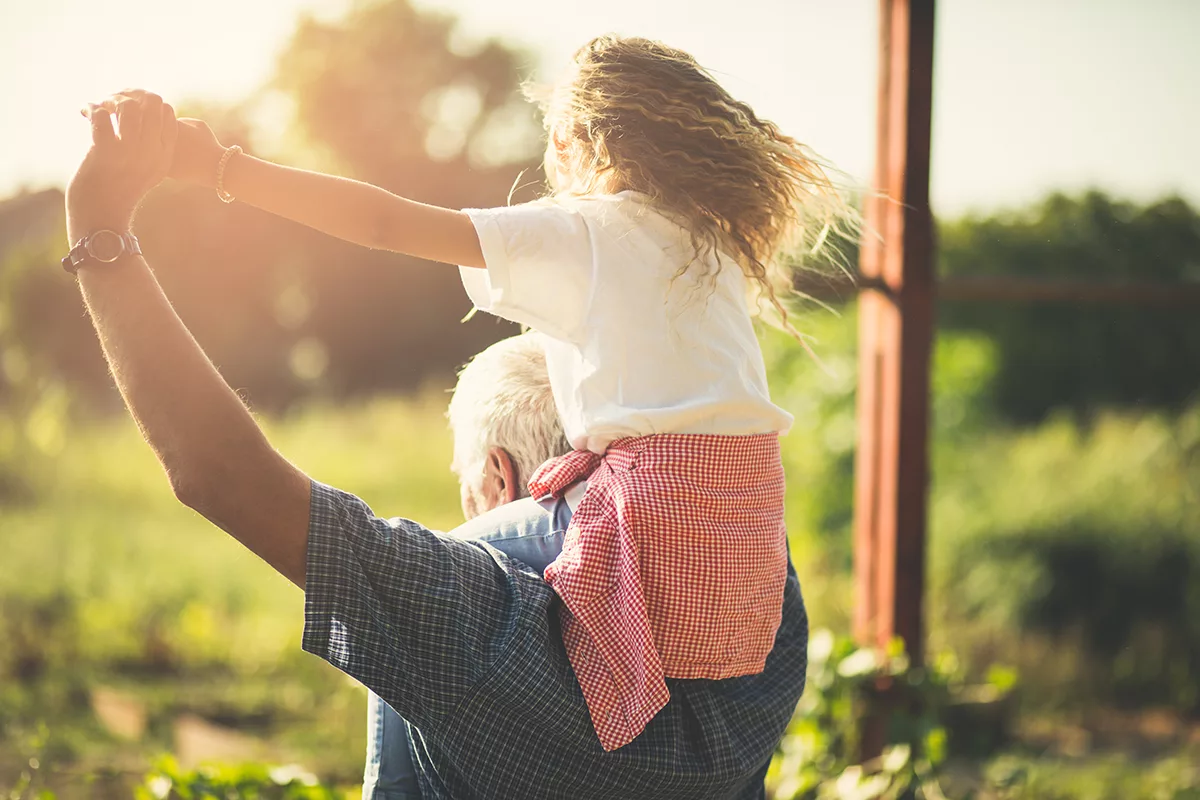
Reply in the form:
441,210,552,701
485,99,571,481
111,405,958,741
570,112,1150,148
0,371,1200,799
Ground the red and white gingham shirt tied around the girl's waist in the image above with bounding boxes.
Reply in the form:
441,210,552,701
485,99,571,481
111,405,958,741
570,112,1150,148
529,433,787,751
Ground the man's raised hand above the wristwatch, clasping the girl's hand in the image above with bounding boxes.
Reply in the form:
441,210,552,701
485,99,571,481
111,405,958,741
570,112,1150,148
67,90,176,243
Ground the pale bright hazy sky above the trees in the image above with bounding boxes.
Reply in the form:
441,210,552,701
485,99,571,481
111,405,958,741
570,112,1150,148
0,0,1200,215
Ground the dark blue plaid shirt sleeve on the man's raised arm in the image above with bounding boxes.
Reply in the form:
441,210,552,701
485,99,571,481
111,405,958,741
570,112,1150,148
302,482,542,730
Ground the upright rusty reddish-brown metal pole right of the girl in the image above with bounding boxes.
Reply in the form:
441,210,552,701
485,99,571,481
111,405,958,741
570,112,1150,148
854,0,934,756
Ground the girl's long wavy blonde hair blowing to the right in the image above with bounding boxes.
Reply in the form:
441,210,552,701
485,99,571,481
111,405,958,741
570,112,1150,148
530,36,857,342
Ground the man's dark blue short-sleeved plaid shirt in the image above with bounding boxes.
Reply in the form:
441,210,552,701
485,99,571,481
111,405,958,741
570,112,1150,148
304,483,808,800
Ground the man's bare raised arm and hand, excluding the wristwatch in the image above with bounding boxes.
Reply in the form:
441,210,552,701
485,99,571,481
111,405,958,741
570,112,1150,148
66,94,310,588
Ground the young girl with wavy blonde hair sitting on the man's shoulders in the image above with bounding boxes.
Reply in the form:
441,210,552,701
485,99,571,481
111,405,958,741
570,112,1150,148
164,36,848,750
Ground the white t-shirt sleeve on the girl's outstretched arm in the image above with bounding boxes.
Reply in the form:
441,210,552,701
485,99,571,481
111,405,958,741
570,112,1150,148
458,201,594,342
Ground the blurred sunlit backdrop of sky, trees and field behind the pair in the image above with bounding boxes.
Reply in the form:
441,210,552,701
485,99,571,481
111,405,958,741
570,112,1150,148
0,0,1200,800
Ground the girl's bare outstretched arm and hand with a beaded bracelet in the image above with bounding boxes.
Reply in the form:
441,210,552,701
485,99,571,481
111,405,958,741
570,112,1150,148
170,113,484,267
